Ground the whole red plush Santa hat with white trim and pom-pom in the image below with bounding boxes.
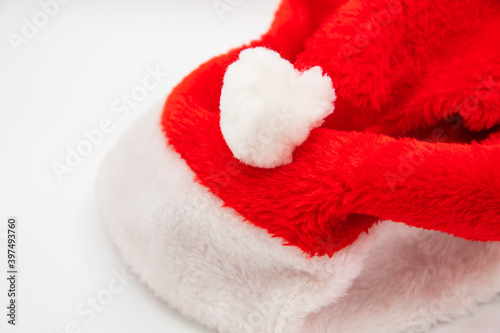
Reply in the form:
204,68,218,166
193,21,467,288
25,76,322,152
97,0,500,333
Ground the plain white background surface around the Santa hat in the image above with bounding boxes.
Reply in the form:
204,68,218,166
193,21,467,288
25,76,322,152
0,0,500,333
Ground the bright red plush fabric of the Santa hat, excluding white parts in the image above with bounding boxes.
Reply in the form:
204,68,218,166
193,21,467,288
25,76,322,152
162,0,500,255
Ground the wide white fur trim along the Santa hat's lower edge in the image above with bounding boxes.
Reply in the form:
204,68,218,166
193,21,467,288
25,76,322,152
97,101,500,333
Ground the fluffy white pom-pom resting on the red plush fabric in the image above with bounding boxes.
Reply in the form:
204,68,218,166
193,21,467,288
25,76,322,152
220,47,335,168
